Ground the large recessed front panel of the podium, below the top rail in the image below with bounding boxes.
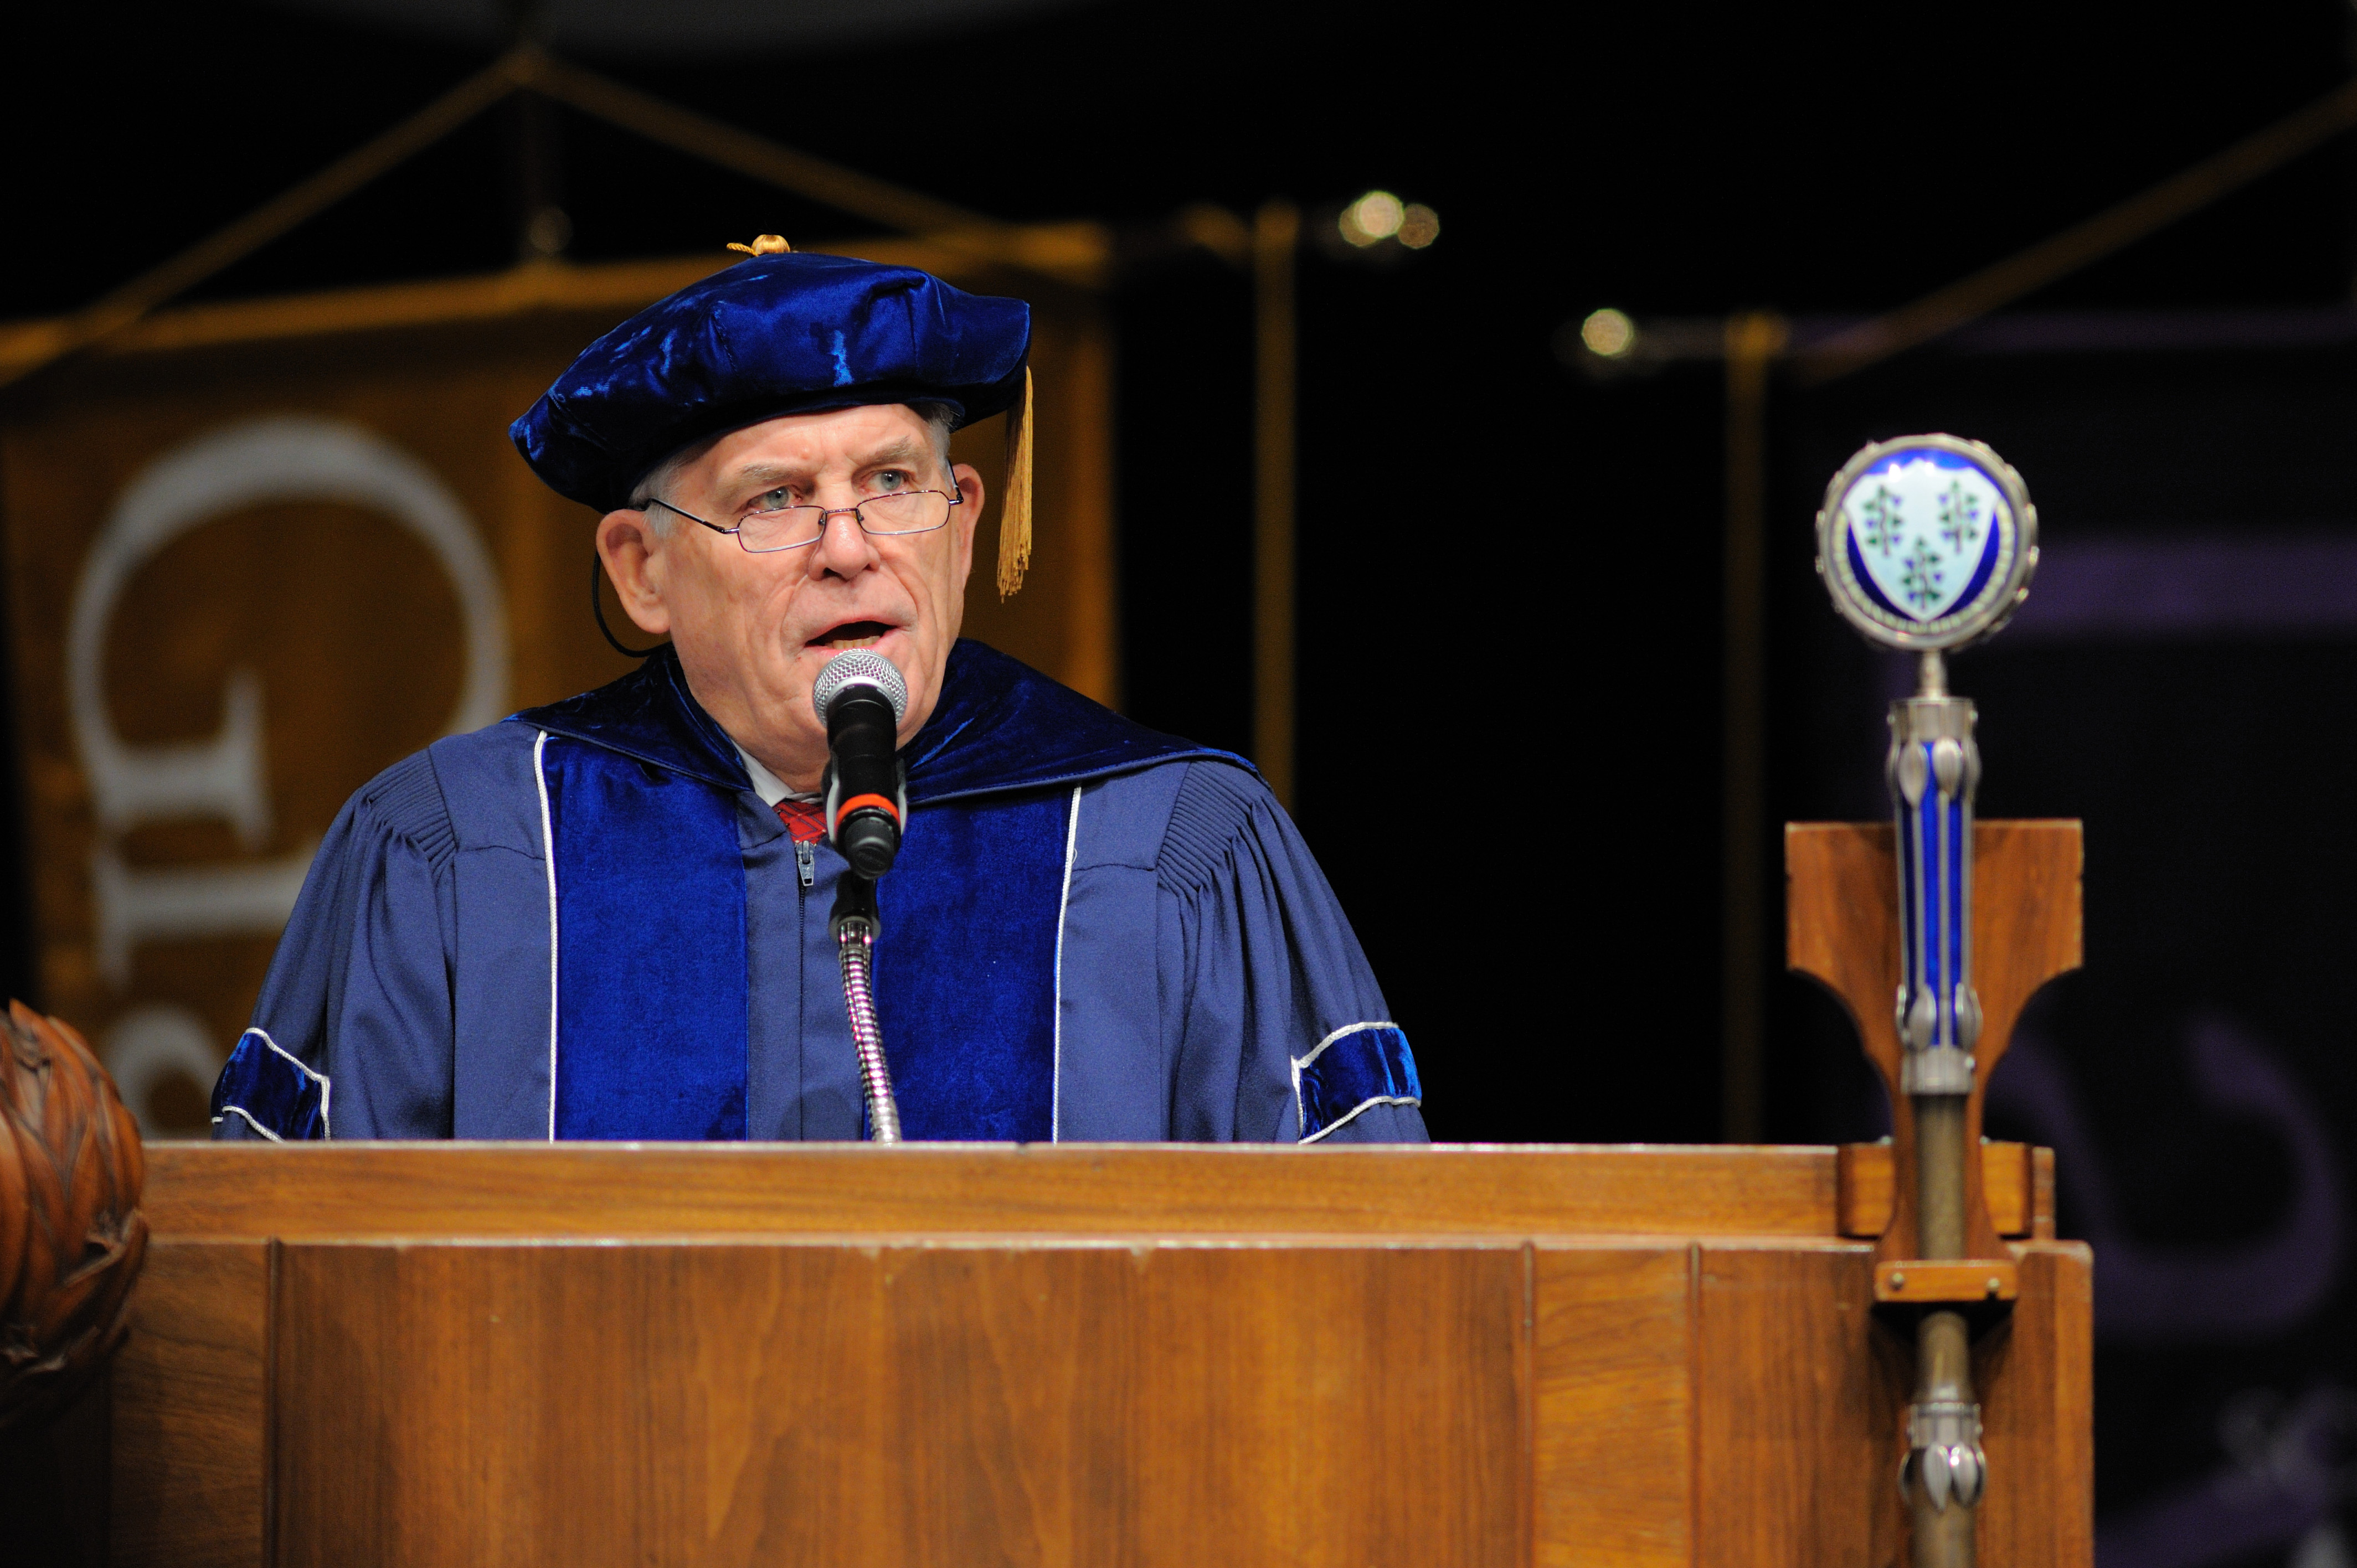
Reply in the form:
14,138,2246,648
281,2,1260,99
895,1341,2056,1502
276,1242,1527,1568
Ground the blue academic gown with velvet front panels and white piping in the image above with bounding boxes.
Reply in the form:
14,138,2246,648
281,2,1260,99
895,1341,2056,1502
212,641,1426,1141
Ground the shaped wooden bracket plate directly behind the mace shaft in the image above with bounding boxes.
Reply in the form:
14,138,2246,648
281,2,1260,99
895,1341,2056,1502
1784,821,2083,1257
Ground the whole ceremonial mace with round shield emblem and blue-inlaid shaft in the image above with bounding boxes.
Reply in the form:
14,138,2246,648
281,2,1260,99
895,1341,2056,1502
1817,436,2039,1568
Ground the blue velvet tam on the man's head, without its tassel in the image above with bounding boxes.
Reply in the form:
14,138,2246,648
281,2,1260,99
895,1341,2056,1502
507,252,1030,512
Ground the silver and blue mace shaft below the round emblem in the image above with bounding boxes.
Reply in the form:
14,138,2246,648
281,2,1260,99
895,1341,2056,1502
1890,651,1989,1568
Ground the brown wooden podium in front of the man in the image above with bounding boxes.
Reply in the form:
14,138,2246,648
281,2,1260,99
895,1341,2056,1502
50,1143,2091,1568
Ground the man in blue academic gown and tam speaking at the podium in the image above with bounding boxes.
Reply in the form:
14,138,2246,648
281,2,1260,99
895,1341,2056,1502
212,247,1424,1143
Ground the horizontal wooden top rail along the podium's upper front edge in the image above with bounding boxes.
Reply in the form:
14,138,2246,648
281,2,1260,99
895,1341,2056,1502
146,1143,1836,1240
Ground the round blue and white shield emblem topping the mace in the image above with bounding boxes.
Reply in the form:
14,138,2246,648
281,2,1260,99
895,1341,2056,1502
1817,436,2039,651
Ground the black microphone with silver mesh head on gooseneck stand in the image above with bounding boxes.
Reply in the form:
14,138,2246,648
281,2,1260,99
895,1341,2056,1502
811,648,908,1143
